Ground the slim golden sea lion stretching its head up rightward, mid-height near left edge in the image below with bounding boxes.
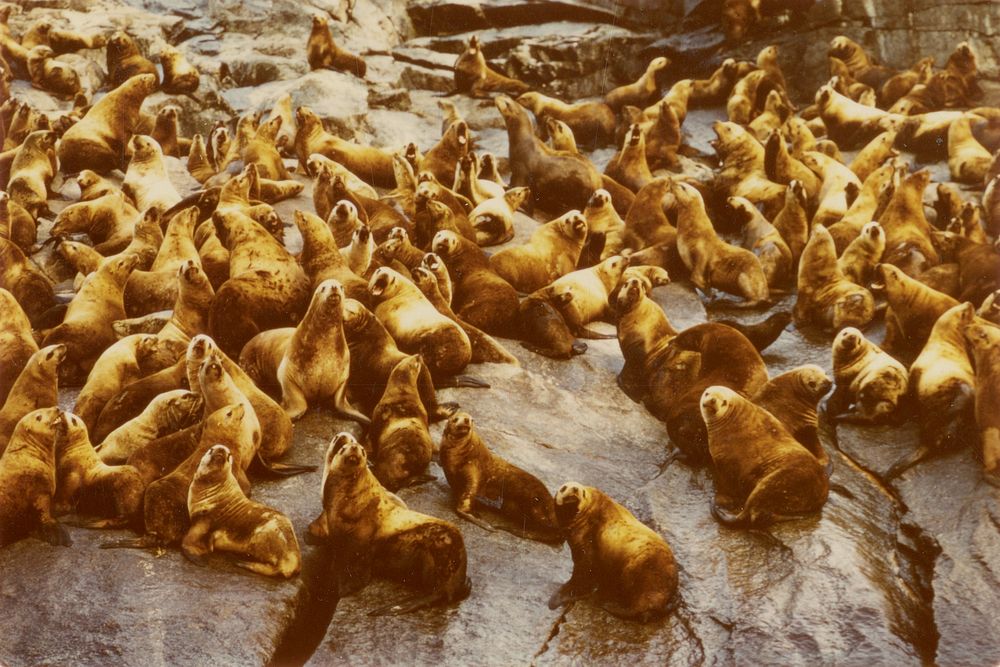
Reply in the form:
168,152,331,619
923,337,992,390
43,254,139,385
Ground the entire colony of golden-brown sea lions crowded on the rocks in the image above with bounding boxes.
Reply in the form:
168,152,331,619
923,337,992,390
0,3,1000,620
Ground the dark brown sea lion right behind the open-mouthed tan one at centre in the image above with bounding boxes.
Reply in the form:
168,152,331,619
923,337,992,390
431,231,520,336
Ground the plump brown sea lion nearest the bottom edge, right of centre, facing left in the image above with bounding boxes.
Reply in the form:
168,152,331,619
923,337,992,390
549,482,677,623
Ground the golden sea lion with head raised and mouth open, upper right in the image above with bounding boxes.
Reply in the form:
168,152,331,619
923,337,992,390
712,121,785,216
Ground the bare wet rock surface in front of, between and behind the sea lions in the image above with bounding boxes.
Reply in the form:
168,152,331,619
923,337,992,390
0,0,1000,666
